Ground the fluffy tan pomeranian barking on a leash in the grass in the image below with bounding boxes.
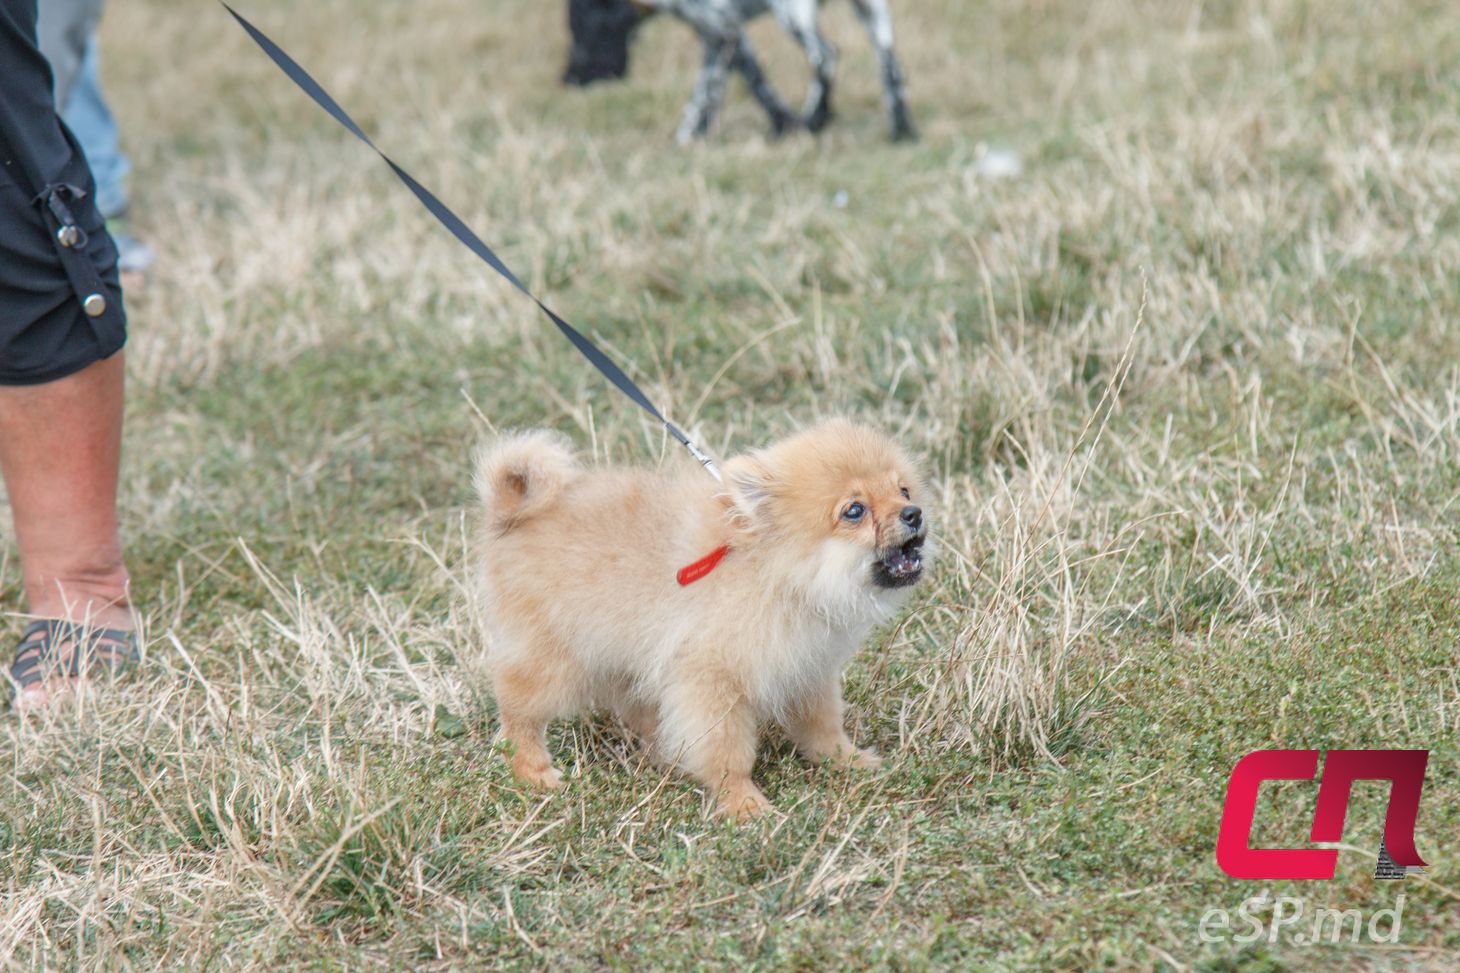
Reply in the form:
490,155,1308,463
476,419,930,818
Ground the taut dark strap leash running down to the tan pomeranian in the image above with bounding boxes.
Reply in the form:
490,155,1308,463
219,0,720,479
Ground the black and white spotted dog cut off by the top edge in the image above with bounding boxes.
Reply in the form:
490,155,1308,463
564,0,917,143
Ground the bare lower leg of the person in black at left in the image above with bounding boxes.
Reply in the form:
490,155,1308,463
0,354,134,709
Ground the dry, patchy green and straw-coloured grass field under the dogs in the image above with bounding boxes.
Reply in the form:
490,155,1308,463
0,0,1460,973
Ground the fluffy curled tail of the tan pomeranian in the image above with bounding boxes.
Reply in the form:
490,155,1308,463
476,430,580,532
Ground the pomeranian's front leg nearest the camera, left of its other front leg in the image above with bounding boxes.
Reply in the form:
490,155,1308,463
661,687,771,821
